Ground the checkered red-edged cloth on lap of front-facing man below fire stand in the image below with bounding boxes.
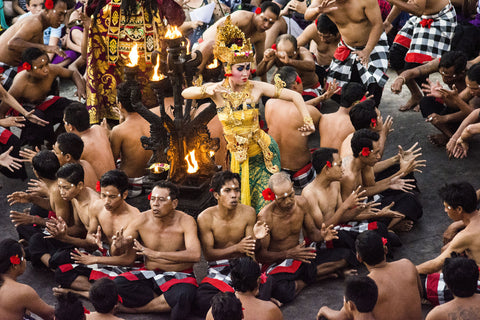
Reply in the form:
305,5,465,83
119,269,198,292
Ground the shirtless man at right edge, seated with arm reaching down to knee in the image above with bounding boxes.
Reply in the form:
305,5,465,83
417,182,480,305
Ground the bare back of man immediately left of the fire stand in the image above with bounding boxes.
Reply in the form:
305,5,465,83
110,113,153,178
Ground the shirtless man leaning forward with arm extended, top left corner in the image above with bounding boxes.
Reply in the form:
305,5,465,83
0,0,67,90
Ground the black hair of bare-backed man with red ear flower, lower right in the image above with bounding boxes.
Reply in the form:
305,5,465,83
355,230,385,266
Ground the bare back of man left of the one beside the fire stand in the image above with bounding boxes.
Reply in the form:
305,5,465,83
80,125,115,177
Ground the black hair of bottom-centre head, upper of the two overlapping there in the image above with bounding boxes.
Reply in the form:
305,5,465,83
230,257,261,292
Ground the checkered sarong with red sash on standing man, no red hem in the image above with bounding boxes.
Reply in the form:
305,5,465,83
327,32,388,87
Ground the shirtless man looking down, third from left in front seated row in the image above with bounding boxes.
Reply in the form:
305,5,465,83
54,170,140,298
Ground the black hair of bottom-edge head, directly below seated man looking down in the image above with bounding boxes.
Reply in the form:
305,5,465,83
90,278,118,313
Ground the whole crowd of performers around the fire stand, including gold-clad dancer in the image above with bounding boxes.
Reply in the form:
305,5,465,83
0,0,480,320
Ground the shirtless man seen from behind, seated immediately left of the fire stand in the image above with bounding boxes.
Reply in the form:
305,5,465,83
110,82,153,197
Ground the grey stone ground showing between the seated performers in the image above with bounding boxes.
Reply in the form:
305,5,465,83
0,72,480,320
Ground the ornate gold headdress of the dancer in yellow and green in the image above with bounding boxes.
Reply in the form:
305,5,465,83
213,16,254,65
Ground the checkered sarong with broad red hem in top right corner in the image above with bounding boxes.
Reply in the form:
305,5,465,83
394,3,457,63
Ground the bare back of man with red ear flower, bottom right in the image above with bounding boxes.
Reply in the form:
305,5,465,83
368,259,422,320
